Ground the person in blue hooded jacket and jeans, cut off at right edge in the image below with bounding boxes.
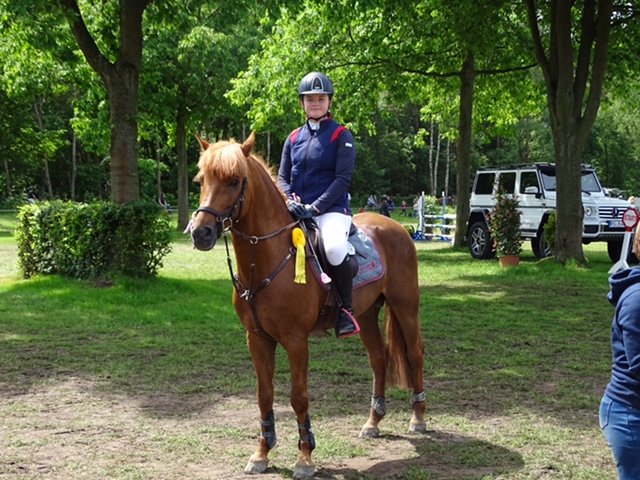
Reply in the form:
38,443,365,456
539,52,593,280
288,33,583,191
600,225,640,480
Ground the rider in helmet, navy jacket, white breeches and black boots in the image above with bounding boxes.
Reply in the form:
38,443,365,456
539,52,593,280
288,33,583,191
278,72,360,338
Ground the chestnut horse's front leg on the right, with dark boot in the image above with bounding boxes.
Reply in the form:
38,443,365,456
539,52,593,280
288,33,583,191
283,338,316,478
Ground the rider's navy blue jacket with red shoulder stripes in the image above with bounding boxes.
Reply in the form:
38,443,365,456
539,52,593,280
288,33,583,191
278,118,356,215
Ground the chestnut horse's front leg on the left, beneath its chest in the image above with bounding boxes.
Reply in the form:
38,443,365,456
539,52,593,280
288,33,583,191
244,333,277,473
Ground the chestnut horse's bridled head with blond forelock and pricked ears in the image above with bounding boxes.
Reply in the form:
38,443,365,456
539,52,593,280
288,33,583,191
191,132,256,250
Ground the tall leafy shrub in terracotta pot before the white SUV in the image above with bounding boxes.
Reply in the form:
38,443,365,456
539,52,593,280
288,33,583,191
489,189,523,266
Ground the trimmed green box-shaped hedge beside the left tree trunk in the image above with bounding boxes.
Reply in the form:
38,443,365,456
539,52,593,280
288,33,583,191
16,201,171,278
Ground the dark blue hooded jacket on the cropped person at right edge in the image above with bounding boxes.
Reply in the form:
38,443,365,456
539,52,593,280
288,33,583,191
605,268,640,409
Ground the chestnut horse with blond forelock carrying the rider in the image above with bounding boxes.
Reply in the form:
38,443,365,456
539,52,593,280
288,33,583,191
191,132,426,478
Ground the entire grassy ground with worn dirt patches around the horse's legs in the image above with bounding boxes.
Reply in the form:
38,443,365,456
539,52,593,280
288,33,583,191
0,215,616,480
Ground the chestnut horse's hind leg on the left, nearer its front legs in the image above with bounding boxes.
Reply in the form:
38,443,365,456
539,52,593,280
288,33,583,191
358,305,387,438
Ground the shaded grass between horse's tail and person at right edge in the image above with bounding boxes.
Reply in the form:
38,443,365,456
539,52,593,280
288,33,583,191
421,251,613,429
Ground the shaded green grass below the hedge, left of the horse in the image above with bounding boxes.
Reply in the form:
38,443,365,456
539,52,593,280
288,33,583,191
0,277,255,408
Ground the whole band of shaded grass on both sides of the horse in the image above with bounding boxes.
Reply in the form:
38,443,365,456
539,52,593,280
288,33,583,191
0,250,612,438
